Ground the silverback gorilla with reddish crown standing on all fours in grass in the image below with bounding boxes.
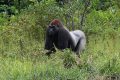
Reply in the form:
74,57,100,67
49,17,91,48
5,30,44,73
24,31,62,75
45,19,86,56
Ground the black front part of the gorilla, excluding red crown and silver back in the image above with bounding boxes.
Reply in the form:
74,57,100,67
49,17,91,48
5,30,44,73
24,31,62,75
45,26,75,55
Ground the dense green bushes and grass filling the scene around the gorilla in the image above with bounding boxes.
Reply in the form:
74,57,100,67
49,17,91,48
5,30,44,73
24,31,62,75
0,0,120,80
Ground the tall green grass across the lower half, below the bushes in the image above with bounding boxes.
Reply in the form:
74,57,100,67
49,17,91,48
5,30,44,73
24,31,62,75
0,28,120,80
